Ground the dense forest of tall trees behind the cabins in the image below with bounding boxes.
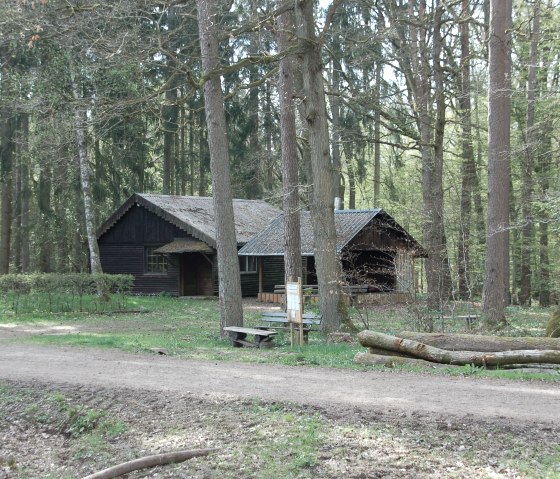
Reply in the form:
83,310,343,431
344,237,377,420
0,0,560,320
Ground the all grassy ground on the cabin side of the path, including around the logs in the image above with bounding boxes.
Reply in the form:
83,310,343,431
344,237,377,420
0,297,560,380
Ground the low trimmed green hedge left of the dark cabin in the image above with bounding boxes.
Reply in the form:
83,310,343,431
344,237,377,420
0,273,134,314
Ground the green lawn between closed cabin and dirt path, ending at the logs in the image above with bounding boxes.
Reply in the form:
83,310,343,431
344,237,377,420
4,297,360,367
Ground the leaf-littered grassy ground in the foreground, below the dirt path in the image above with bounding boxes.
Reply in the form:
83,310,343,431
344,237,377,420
0,378,560,479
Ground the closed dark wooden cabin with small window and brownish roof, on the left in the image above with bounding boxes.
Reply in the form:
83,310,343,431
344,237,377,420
97,194,280,296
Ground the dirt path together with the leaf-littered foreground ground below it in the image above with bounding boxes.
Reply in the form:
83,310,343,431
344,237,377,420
0,328,560,479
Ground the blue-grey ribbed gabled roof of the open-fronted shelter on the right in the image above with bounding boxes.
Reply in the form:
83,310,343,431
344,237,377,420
239,208,425,256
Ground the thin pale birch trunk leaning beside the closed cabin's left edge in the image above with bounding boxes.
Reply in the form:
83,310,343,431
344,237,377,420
70,64,103,274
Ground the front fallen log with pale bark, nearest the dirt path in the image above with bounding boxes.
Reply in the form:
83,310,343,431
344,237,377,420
358,331,560,367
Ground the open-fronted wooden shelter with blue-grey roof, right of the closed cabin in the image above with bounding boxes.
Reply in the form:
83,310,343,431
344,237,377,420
239,209,426,300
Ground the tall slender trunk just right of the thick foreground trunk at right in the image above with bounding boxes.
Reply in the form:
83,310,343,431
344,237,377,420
519,0,541,306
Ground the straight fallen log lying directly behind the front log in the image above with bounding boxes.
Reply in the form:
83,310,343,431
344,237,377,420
397,331,560,353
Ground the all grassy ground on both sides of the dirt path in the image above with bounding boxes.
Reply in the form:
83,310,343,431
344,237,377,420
0,297,560,479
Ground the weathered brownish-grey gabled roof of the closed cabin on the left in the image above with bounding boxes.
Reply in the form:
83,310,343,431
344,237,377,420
97,193,280,248
